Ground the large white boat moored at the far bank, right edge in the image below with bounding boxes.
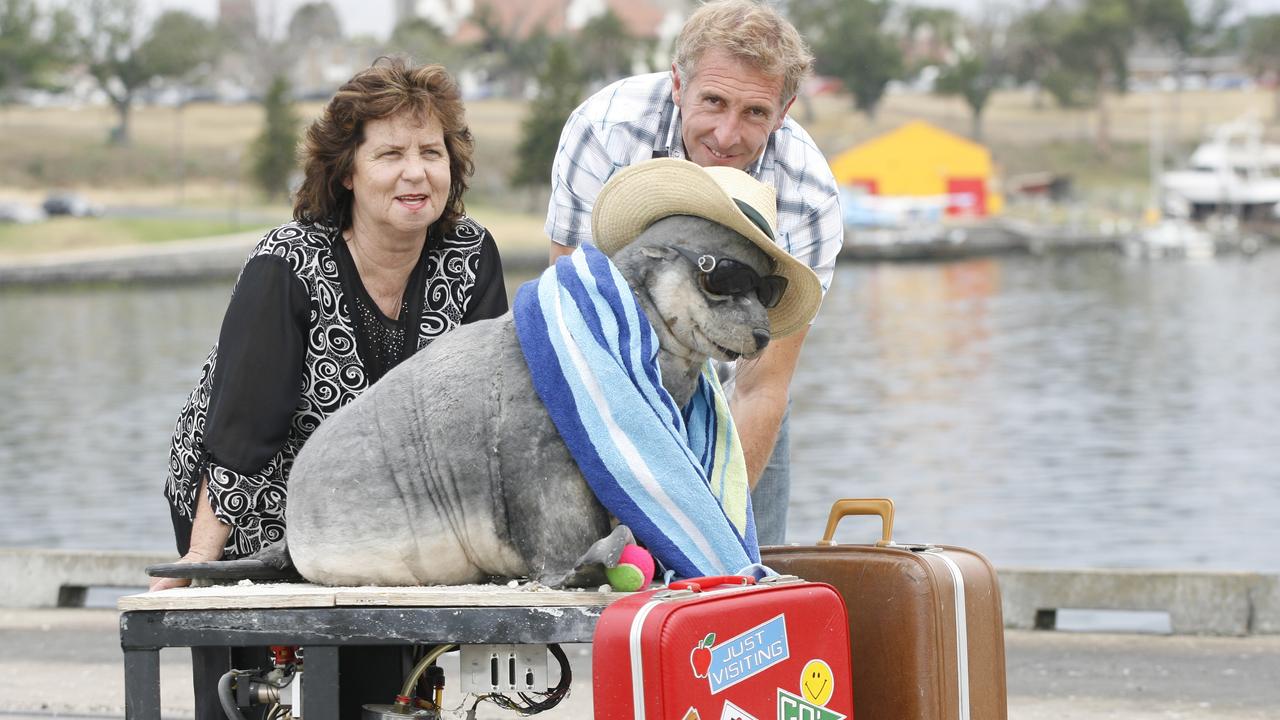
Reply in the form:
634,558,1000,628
1160,119,1280,220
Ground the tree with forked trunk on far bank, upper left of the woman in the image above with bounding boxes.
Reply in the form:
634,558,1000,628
77,0,214,145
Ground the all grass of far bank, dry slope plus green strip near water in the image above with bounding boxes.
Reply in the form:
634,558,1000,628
0,83,1275,254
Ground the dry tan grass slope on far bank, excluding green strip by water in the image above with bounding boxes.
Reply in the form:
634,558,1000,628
10,90,1272,196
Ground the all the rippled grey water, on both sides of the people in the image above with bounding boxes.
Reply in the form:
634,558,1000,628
0,250,1280,571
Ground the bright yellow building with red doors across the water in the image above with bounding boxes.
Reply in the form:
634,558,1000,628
831,120,1004,218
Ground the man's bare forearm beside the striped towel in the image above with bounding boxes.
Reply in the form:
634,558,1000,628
730,327,809,489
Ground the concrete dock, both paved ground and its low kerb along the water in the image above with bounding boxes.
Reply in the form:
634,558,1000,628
0,548,1280,720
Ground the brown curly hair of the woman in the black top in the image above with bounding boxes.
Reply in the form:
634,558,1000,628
293,58,475,229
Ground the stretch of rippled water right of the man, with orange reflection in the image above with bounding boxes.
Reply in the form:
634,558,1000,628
790,252,1280,570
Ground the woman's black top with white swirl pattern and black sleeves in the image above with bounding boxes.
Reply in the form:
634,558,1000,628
165,218,507,559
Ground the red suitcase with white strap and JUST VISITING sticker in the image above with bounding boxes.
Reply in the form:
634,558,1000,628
591,577,854,720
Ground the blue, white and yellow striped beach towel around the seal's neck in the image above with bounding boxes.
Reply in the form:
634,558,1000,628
513,245,759,578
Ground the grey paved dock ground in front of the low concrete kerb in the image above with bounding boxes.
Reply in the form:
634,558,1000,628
0,609,1280,720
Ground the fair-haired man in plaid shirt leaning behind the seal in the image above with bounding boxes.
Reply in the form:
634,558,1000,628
545,0,844,544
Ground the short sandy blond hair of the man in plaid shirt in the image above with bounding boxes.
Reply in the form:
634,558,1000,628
676,0,813,105
